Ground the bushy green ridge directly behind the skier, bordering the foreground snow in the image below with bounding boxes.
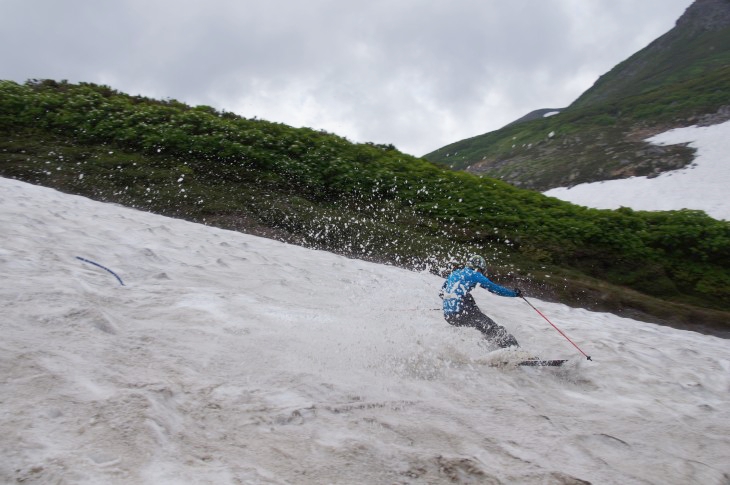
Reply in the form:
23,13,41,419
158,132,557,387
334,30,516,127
0,81,730,332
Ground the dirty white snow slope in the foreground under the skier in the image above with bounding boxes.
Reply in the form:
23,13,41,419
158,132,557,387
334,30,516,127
0,175,730,485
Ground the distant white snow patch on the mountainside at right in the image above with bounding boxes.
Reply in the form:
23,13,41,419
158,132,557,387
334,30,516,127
545,121,730,220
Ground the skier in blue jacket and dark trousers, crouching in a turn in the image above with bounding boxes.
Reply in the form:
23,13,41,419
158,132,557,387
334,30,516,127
440,255,522,348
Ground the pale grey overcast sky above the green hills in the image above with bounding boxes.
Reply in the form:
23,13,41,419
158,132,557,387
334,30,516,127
0,0,692,156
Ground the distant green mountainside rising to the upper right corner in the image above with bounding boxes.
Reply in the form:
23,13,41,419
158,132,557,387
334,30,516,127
425,0,730,190
